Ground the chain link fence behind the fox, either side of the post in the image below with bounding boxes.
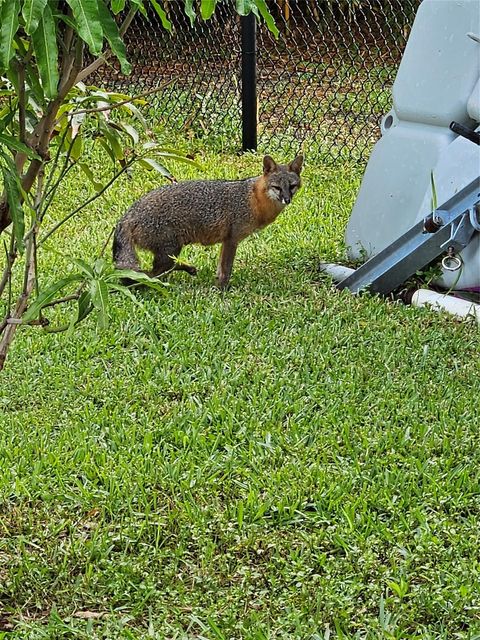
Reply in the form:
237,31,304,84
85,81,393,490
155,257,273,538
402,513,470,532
96,0,420,161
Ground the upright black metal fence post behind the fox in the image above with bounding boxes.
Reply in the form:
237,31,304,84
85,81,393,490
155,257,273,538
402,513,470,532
241,13,257,151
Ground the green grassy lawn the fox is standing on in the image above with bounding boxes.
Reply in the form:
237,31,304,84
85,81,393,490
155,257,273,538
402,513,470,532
0,141,480,640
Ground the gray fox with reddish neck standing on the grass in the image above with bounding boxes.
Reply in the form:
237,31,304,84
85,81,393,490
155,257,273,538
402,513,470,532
113,156,303,289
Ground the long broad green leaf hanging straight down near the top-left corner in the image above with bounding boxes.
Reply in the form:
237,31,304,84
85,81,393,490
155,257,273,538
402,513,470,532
32,4,58,98
